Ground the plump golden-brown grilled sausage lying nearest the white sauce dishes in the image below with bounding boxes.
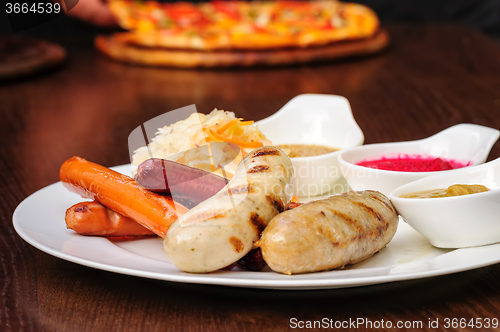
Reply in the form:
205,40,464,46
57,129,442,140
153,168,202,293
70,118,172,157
257,190,398,274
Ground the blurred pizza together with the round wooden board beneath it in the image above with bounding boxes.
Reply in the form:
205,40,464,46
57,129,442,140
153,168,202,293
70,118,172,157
96,0,388,67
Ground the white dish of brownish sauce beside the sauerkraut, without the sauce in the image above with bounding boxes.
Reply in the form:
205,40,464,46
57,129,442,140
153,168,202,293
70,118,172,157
257,94,364,197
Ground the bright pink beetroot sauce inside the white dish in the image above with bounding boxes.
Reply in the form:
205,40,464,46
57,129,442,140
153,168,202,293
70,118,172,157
356,154,472,172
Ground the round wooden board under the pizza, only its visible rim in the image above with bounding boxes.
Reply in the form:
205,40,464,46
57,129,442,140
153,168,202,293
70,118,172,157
95,29,389,68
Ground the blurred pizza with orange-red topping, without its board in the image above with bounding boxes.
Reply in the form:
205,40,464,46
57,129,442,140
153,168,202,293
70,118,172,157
109,0,379,51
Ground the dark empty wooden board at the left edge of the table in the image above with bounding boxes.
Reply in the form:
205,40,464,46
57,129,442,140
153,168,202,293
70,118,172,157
0,36,66,81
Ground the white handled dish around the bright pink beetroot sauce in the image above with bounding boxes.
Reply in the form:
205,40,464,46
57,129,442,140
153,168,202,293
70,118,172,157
339,123,500,195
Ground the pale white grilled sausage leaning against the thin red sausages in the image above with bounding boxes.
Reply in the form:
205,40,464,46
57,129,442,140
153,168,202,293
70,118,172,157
164,147,293,273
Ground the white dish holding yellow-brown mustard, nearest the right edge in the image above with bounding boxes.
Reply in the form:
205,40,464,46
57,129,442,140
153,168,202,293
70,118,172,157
390,158,500,248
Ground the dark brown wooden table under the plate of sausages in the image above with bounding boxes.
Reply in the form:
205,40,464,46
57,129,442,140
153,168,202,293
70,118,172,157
0,24,500,331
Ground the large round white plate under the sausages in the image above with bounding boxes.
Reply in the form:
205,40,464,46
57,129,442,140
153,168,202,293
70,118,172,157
13,165,500,289
